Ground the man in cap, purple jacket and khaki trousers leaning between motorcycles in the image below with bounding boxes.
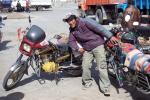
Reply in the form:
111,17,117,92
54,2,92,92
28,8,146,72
63,13,117,96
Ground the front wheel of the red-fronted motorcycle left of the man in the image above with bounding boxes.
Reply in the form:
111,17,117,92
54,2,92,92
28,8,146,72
3,61,27,91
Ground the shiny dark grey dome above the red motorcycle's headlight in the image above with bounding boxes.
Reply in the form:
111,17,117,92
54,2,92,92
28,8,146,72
26,25,46,43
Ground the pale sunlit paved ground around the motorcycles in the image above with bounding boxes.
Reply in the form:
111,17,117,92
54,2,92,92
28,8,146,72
0,4,150,100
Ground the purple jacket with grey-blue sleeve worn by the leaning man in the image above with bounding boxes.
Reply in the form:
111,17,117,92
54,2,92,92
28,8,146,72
69,18,112,51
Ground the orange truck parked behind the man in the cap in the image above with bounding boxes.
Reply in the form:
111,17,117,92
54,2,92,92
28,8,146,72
77,0,124,24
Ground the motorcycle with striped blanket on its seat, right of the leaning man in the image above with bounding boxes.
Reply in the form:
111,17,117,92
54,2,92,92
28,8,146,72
105,28,150,94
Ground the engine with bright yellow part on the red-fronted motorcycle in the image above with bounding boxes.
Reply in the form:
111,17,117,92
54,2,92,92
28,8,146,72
35,44,70,72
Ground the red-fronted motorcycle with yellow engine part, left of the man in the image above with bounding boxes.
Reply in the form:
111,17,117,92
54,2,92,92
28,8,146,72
3,17,82,90
